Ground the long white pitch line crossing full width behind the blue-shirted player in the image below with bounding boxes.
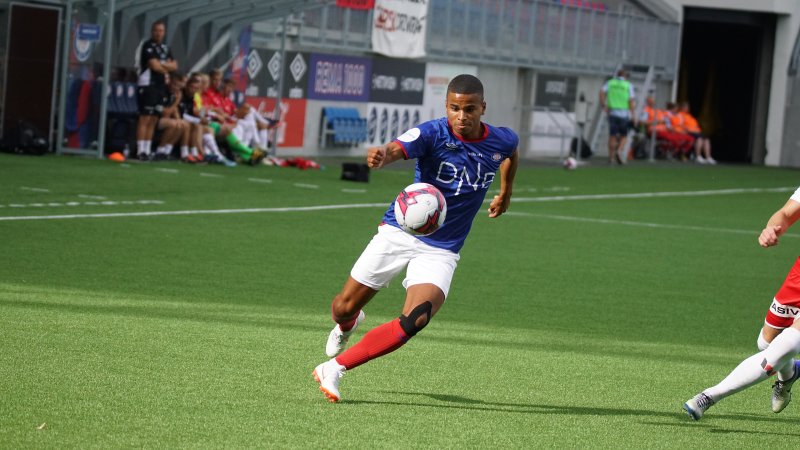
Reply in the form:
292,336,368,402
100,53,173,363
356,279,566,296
0,185,796,222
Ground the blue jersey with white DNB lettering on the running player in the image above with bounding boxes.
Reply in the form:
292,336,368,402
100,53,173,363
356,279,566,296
383,117,519,253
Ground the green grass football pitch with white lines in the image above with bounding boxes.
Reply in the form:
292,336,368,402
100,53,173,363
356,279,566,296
0,155,800,449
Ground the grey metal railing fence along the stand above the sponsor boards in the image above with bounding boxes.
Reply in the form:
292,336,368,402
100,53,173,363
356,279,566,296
299,0,680,79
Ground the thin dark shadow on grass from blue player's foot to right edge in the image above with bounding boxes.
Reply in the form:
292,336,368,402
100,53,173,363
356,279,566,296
343,391,800,428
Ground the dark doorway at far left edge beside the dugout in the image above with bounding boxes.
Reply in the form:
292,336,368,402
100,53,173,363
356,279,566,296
3,4,61,147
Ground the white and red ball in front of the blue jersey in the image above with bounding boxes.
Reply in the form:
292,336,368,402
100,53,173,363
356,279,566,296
394,183,447,236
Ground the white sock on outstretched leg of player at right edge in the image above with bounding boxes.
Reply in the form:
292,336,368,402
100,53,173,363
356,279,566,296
703,328,800,402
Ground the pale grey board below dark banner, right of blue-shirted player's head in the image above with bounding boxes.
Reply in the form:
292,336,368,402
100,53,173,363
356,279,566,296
524,111,575,158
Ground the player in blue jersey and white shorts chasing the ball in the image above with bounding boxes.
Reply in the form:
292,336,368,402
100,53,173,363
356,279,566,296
312,75,519,402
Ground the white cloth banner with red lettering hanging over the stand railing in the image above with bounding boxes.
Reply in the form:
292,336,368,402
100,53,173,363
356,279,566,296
372,0,428,58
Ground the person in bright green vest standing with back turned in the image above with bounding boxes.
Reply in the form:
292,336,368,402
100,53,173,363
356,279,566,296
600,69,635,164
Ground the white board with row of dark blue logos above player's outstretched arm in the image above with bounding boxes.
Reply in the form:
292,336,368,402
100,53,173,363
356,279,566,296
364,102,423,147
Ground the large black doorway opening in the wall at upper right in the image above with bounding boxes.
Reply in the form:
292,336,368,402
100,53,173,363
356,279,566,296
678,8,775,163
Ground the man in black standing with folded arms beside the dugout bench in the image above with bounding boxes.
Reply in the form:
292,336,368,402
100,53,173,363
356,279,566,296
136,20,178,161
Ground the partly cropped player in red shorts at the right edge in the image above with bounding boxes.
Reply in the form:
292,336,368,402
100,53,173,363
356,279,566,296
683,188,800,420
